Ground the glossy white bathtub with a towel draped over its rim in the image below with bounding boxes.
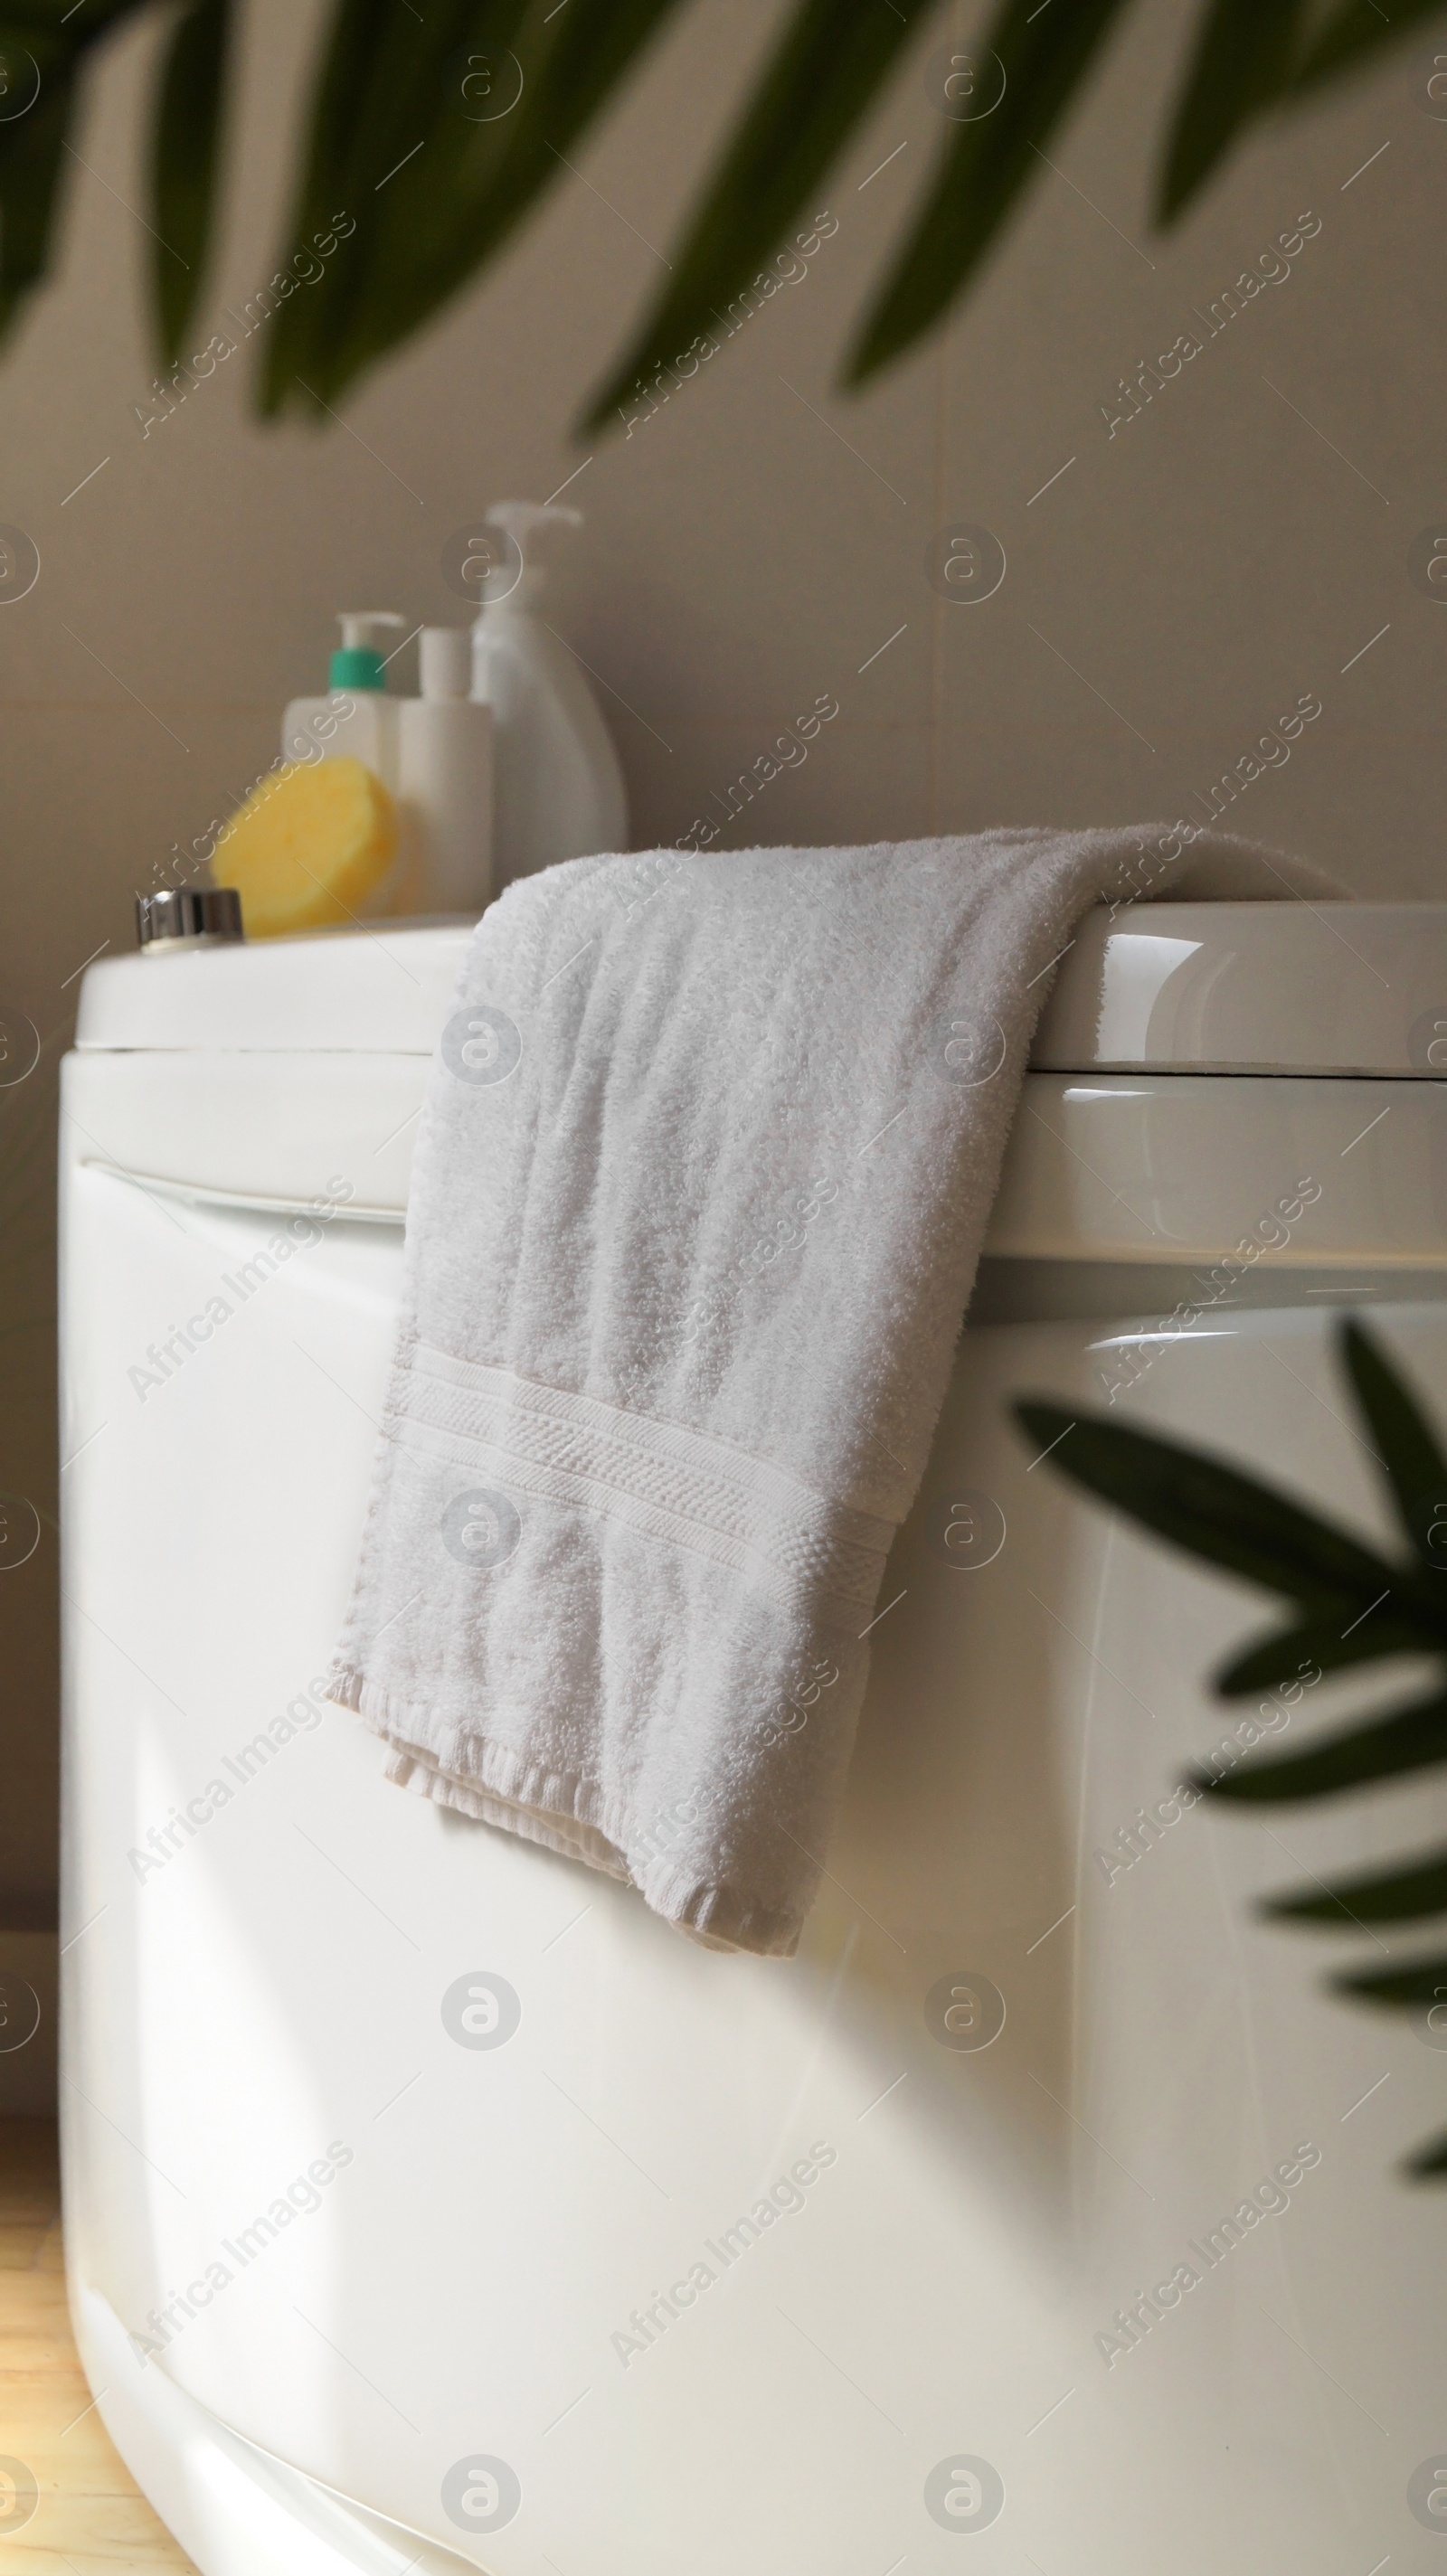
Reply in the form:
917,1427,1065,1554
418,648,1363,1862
61,904,1447,2576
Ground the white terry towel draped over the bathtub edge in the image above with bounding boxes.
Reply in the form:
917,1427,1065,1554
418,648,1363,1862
332,827,1341,1955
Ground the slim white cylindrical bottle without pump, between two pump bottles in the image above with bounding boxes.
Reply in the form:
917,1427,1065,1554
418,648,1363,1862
396,626,492,914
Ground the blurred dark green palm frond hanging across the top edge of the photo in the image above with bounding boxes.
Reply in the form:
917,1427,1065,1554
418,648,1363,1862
0,0,1447,407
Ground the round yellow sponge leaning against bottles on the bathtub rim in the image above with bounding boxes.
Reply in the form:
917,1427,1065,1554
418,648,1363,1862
211,758,396,940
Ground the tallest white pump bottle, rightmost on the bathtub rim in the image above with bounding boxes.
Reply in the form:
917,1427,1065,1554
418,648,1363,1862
471,500,629,892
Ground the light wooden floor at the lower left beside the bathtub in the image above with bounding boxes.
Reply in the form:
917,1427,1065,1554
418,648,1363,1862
0,2120,191,2576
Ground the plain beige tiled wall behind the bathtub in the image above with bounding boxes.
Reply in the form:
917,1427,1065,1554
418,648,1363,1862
0,0,1447,1927
